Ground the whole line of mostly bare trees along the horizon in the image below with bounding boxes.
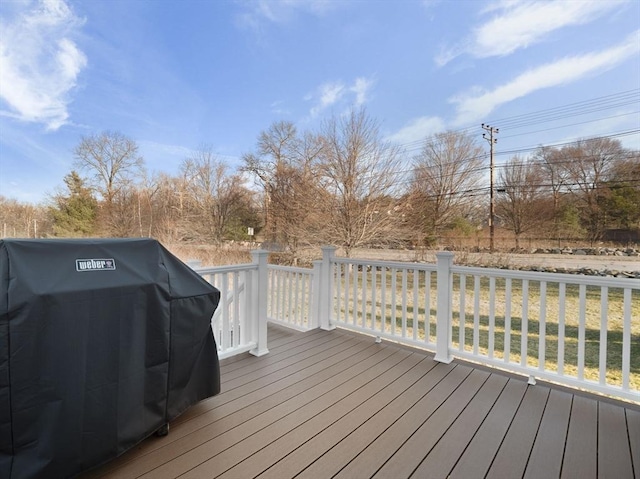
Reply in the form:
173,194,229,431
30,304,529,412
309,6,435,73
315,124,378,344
0,109,640,258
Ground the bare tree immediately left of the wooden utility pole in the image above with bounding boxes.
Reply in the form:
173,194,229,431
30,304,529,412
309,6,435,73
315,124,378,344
411,131,484,246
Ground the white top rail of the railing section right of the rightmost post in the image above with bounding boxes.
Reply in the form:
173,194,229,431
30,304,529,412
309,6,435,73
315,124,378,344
451,265,640,289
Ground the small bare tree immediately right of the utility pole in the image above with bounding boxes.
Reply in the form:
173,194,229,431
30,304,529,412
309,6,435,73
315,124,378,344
496,156,553,249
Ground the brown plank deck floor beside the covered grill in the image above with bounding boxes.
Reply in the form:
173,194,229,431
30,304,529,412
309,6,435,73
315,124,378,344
83,326,640,479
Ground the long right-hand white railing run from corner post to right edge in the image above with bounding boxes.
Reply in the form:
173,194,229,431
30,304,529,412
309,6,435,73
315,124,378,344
323,251,640,402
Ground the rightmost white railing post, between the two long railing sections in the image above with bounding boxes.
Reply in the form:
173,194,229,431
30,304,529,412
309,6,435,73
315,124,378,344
434,251,453,364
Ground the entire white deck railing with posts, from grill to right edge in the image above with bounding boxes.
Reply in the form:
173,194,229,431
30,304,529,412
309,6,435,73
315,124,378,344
197,247,640,402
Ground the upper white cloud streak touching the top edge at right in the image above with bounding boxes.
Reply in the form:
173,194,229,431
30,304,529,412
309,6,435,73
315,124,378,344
435,0,626,66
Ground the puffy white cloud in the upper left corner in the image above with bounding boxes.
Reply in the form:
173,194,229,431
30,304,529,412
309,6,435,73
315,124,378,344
0,0,87,130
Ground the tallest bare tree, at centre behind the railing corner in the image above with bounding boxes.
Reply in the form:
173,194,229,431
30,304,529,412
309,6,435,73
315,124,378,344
317,109,400,256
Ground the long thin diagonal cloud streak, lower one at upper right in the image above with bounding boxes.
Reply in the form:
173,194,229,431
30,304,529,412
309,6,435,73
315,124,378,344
450,30,640,126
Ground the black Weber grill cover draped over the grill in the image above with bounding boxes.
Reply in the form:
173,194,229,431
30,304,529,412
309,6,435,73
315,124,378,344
0,239,220,479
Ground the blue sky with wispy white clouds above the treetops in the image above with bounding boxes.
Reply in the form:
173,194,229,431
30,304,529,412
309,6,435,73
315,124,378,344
0,0,640,203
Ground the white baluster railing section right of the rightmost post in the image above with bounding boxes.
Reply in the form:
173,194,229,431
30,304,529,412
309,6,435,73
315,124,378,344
449,266,640,401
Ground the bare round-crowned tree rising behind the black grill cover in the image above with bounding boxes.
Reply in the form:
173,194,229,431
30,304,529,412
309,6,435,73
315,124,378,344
74,131,144,236
